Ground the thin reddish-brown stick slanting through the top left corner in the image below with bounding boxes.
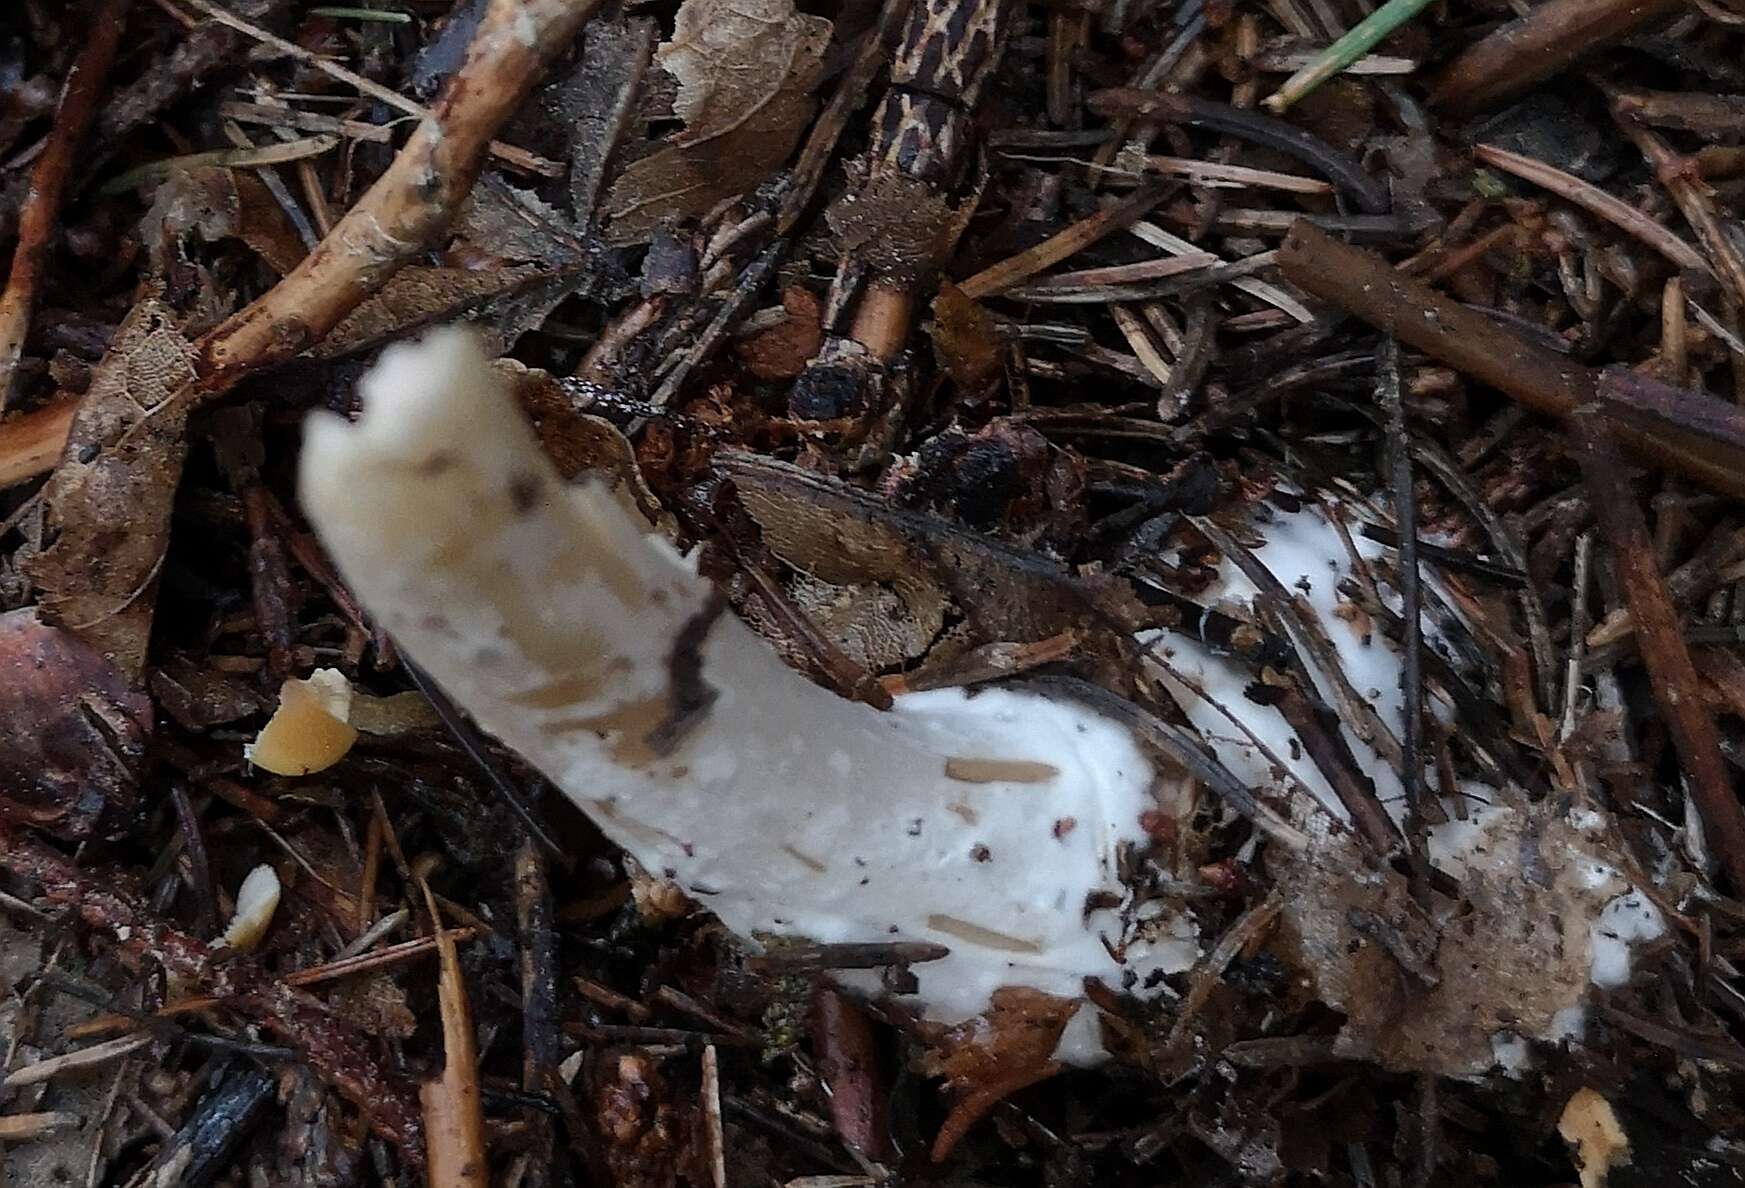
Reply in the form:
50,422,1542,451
0,0,133,412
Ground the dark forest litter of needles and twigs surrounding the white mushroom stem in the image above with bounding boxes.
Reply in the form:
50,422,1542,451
0,0,1745,1185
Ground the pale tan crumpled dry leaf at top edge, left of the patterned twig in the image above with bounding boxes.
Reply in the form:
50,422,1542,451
654,0,831,145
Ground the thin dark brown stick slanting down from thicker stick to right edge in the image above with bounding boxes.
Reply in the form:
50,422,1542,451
1574,408,1745,895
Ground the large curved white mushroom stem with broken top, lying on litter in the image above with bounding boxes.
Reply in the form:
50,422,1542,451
300,328,1197,1062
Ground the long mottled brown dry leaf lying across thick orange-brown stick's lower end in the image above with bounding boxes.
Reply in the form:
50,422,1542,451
24,295,195,680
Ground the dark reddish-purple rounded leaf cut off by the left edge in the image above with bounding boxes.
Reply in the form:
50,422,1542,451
0,607,152,839
